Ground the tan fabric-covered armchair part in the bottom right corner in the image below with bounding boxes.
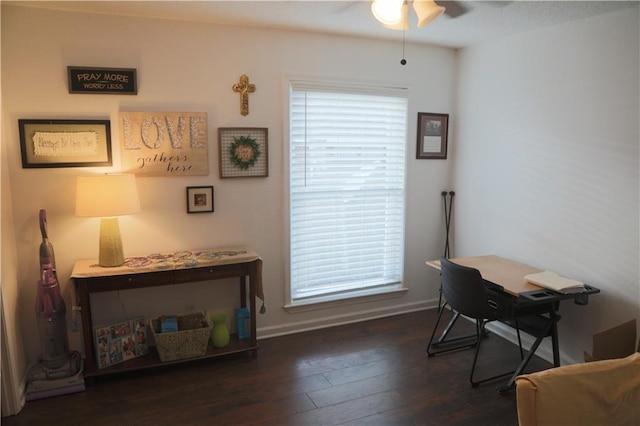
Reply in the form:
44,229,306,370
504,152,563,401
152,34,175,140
516,353,640,426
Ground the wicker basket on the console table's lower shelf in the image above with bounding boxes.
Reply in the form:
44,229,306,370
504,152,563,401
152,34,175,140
151,313,211,362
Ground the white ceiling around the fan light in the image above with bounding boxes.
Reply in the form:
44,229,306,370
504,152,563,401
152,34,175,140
3,0,638,48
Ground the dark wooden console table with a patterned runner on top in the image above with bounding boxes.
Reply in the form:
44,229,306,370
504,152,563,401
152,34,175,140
71,247,264,378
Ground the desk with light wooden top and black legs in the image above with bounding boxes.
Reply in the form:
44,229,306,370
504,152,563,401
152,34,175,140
426,255,600,392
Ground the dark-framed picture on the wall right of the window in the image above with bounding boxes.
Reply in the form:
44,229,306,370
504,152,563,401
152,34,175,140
416,112,449,160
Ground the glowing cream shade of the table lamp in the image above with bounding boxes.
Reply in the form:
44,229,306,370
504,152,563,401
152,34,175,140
76,174,140,217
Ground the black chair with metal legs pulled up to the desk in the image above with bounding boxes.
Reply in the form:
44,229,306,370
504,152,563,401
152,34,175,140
429,258,524,387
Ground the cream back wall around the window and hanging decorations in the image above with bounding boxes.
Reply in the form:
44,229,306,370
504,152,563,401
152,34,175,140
2,5,456,402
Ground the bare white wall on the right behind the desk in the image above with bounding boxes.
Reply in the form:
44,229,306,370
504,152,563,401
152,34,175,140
453,5,640,362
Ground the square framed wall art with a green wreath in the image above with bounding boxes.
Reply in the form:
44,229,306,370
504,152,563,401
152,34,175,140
218,127,269,178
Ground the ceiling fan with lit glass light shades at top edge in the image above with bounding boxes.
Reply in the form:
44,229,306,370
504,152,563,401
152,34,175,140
371,0,467,30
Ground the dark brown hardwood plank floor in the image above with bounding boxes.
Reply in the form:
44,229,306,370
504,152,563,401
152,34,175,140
2,310,551,426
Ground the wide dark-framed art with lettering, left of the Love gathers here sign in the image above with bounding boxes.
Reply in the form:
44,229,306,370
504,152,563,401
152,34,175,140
18,119,112,169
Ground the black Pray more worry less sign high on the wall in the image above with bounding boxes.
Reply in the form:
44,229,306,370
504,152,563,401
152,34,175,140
67,67,138,95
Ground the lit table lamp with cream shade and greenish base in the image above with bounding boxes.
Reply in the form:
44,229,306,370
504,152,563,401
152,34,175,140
76,174,140,267
